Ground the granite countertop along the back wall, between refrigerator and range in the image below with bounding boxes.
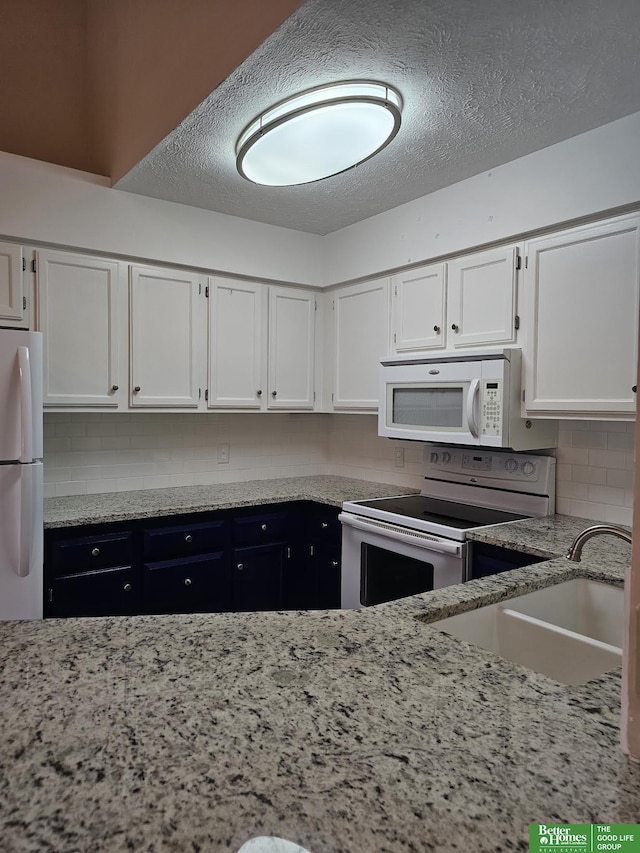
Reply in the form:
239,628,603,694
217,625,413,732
44,475,418,529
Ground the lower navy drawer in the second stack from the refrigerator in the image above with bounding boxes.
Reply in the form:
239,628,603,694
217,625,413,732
142,551,229,613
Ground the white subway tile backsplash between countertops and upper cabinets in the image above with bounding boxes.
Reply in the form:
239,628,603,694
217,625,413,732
44,412,635,525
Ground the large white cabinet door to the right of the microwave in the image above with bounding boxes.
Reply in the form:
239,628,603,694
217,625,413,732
524,216,640,419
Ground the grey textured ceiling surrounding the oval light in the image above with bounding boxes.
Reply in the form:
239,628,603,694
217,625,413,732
116,0,640,234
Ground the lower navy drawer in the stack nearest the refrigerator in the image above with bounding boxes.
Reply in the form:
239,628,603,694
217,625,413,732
45,566,142,617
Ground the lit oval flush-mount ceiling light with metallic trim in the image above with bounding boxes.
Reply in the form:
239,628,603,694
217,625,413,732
236,81,402,187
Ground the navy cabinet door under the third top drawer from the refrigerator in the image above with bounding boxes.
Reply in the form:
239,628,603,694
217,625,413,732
231,542,290,611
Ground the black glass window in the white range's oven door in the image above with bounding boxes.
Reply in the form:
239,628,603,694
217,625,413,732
360,542,434,607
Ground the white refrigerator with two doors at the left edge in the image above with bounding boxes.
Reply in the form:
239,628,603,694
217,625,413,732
0,329,44,619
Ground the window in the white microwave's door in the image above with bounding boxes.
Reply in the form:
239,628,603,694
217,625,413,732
388,382,469,432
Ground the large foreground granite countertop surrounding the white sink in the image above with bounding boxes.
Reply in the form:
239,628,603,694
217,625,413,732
0,487,640,853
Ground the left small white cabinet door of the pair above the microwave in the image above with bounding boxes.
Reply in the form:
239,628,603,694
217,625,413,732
391,264,446,353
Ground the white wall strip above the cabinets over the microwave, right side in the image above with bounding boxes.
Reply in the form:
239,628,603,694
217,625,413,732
323,108,640,285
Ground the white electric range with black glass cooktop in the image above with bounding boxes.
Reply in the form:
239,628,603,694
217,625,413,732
340,445,556,609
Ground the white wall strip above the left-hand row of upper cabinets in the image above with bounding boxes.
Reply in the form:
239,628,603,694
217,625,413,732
0,152,322,285
